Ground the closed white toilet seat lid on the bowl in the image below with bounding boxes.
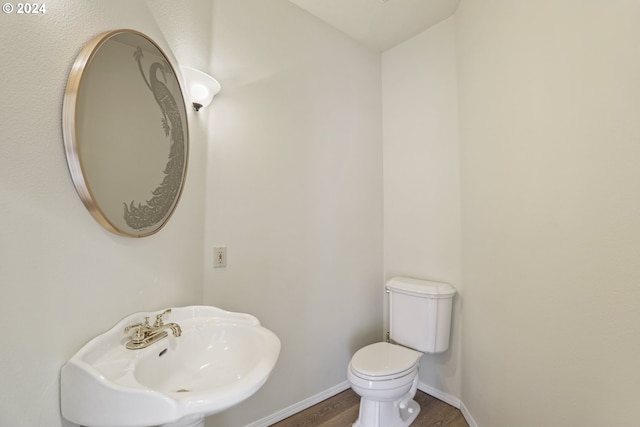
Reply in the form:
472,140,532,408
350,342,422,381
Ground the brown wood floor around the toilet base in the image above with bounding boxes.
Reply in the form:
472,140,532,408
271,389,469,427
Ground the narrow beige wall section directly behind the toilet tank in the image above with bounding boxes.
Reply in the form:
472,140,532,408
382,18,464,403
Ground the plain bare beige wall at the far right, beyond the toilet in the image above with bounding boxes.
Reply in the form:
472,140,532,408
456,0,640,427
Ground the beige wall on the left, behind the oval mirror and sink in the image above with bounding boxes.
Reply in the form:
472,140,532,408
0,0,208,427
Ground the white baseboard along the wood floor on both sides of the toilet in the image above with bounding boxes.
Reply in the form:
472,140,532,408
245,381,478,427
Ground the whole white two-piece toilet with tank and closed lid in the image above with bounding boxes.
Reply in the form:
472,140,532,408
347,277,456,427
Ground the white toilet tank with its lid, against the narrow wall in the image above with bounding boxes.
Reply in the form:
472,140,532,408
386,277,456,353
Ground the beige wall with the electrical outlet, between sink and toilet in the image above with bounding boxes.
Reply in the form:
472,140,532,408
204,0,383,426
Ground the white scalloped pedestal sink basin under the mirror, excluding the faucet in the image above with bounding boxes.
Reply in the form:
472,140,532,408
60,306,280,427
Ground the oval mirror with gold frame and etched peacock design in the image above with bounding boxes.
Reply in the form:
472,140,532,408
62,30,189,237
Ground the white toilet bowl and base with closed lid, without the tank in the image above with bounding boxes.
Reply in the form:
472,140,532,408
347,342,422,427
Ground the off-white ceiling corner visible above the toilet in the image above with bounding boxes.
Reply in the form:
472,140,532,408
289,0,460,52
